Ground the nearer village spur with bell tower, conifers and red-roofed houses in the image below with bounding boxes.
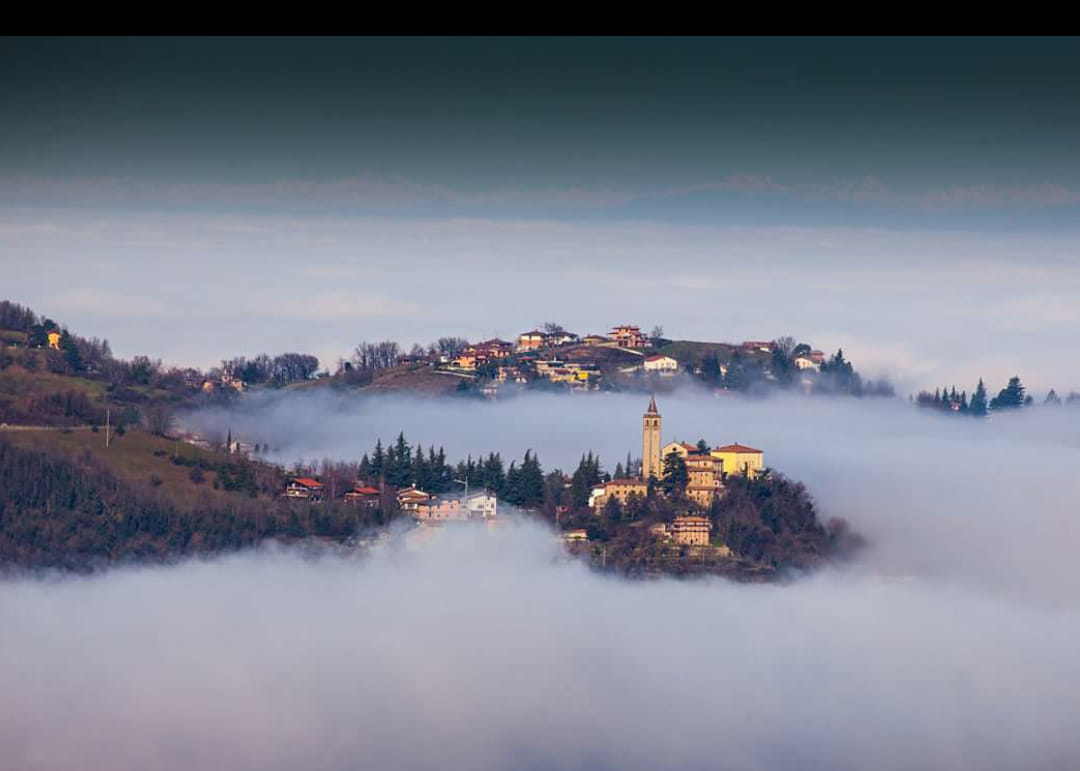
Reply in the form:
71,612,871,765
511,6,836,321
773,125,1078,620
263,398,850,579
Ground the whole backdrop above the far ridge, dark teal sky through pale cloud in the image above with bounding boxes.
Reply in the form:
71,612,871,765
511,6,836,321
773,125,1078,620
0,38,1080,392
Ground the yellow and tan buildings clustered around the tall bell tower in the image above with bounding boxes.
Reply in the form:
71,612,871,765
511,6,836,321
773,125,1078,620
589,398,765,545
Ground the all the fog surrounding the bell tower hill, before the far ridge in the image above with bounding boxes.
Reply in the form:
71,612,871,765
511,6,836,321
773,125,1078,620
6,390,1080,771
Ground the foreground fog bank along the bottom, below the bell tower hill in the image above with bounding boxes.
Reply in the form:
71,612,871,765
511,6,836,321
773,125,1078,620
0,528,1080,771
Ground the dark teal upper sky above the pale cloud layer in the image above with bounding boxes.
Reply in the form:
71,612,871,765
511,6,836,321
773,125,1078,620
6,39,1080,222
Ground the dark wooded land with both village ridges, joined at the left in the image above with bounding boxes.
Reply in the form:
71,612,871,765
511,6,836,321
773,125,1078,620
0,293,852,578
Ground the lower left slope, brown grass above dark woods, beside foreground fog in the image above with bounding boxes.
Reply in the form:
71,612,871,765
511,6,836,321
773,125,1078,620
0,430,384,571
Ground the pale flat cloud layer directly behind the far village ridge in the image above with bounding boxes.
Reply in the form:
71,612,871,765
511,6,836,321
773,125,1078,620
0,209,1080,392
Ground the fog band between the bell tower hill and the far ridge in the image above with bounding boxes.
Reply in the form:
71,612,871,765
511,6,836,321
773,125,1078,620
191,390,1080,608
